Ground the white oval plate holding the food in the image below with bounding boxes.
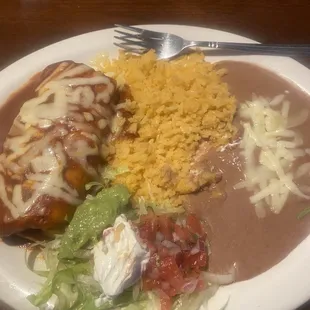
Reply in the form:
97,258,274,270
0,25,310,310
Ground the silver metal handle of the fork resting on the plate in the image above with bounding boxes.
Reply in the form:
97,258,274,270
188,41,310,56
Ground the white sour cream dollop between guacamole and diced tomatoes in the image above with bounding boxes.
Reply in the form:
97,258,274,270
94,214,150,297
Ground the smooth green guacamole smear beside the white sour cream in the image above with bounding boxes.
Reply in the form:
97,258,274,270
58,185,130,259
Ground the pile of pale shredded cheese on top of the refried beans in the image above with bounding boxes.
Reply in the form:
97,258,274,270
235,95,310,217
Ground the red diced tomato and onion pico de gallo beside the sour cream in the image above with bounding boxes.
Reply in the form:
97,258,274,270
138,209,208,310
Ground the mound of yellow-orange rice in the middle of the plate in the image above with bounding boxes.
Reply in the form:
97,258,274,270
95,52,236,206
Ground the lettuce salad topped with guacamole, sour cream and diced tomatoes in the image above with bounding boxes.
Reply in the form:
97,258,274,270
28,185,228,310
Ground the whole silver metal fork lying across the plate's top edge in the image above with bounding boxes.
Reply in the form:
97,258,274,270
114,24,310,59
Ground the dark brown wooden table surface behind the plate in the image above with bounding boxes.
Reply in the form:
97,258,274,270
0,0,310,310
